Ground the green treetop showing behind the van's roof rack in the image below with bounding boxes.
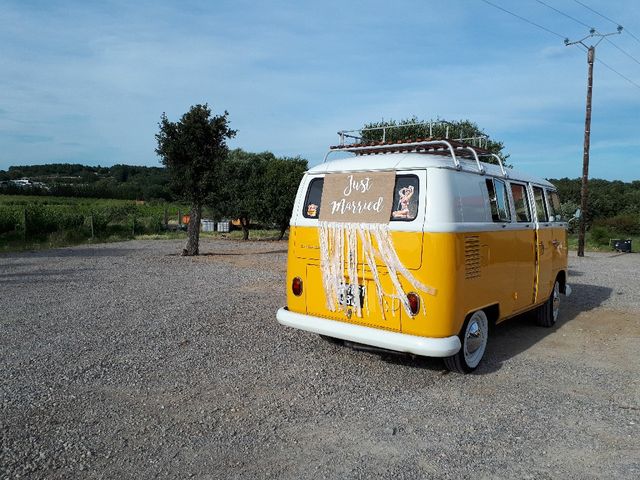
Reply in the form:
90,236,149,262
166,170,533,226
362,117,509,166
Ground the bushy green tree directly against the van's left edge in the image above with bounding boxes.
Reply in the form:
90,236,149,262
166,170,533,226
258,157,308,240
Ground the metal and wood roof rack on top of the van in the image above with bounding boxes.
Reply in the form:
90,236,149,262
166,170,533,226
324,122,508,177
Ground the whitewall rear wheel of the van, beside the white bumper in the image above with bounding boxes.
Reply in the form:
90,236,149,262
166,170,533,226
444,310,489,373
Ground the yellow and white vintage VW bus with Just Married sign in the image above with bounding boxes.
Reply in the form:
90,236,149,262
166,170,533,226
277,129,570,373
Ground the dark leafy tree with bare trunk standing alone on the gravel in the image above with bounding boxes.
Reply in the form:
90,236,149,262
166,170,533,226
156,104,236,256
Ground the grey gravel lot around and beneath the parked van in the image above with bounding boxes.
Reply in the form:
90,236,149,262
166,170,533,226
0,241,640,479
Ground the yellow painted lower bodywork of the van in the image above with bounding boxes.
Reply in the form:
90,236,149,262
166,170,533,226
287,226,567,338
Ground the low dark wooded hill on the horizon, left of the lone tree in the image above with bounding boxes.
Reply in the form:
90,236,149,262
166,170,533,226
0,163,174,200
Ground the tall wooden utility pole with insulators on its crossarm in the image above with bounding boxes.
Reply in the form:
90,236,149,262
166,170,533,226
564,25,622,257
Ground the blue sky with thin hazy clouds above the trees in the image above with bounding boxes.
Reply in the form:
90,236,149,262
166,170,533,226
0,0,640,181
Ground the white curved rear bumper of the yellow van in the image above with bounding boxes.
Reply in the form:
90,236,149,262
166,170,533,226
276,308,460,357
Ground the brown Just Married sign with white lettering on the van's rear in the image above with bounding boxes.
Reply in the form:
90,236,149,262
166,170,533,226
320,172,396,223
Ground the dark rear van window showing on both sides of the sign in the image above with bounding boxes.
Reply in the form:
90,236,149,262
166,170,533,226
302,175,420,222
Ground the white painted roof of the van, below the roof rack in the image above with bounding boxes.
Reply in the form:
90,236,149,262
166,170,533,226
308,152,555,188
